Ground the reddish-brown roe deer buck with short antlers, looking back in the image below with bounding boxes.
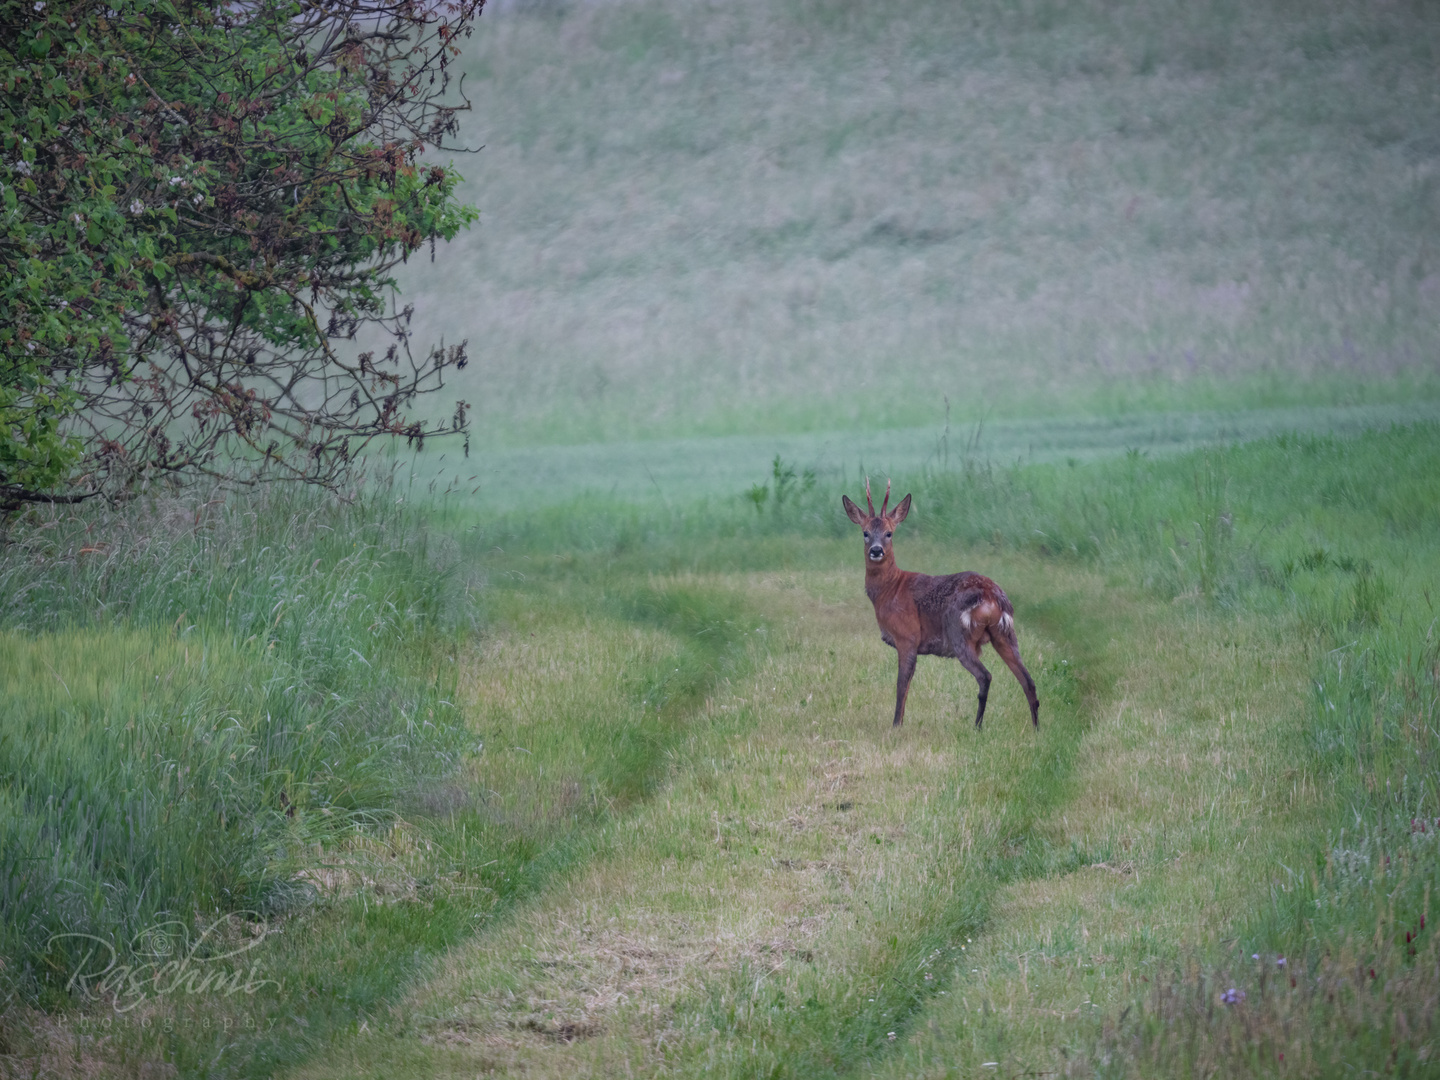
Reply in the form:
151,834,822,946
841,477,1040,730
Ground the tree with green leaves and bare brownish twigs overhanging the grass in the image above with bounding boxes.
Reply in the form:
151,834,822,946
0,0,484,511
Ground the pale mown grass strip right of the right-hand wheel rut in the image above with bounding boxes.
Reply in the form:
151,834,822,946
877,602,1328,1079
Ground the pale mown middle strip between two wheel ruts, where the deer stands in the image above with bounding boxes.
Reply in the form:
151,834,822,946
277,563,1123,1077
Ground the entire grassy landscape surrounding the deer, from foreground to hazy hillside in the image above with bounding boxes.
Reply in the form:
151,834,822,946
0,0,1440,1079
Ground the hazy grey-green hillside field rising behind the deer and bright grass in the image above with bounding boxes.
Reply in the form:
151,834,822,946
388,0,1440,478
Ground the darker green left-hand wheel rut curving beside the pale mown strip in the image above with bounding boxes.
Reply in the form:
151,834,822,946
98,577,763,1077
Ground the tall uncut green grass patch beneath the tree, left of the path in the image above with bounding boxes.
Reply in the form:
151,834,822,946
0,491,468,999
